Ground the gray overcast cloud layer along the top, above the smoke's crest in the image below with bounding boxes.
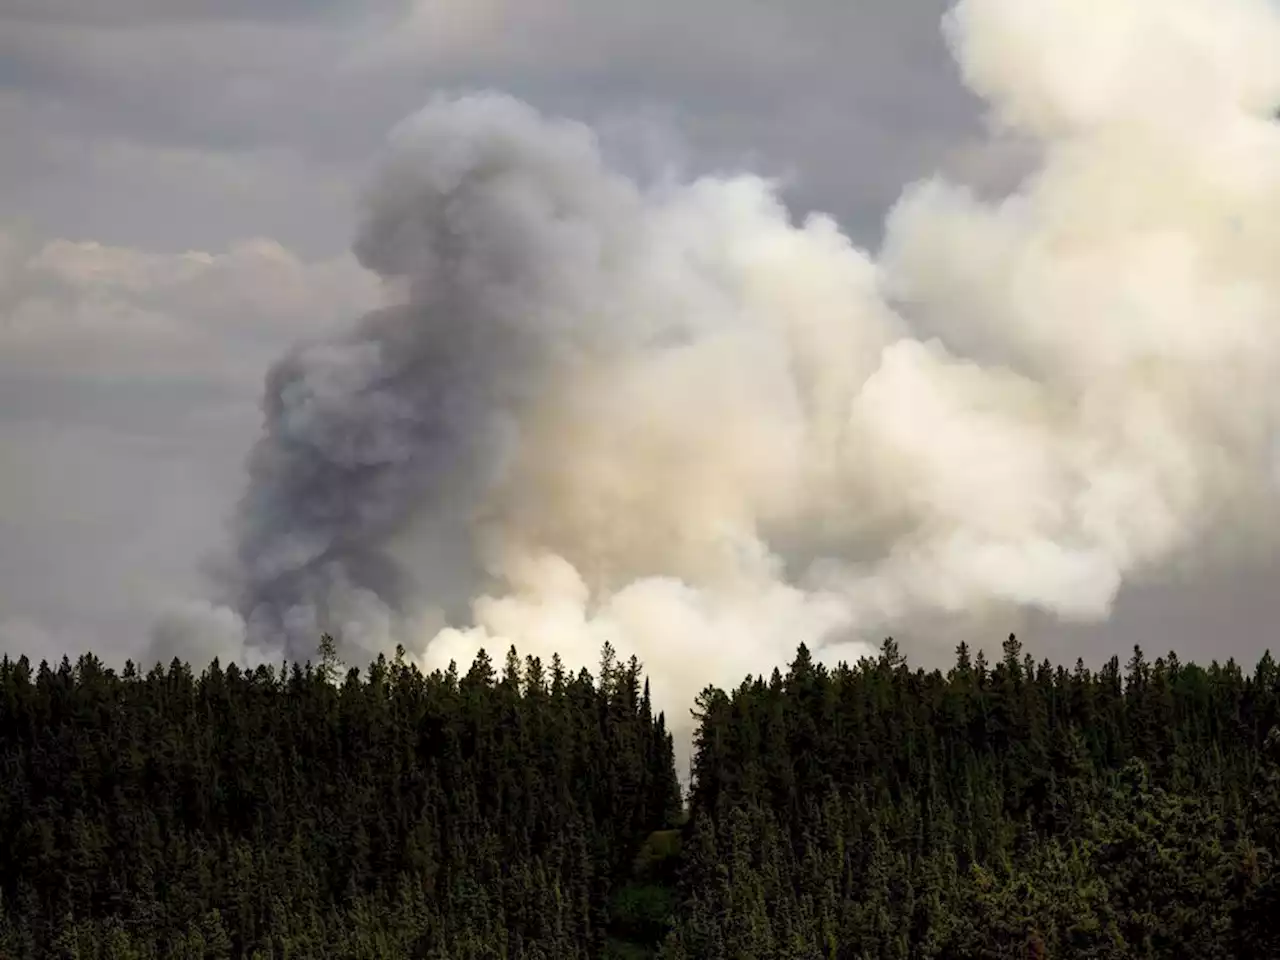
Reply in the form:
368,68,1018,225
0,0,977,252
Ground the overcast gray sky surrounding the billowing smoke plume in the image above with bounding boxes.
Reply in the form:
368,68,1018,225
0,0,1280,675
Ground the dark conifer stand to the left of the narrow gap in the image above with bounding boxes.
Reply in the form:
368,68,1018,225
0,644,680,960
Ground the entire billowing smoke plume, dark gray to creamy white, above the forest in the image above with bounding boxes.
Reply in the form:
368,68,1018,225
183,0,1280,742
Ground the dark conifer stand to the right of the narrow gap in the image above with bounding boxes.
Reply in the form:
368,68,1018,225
663,636,1280,960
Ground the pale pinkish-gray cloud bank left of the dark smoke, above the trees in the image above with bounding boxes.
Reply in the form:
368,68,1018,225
0,226,378,655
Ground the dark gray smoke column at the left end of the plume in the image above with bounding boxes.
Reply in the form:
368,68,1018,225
227,96,639,657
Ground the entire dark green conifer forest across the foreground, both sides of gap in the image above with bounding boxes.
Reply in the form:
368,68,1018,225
0,636,1280,960
